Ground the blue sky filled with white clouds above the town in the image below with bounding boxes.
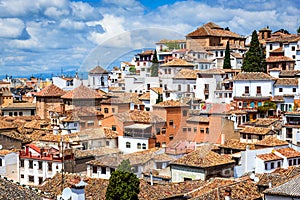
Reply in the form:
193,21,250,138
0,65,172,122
0,0,300,76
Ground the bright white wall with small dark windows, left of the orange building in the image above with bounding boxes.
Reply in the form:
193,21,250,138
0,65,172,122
118,136,149,153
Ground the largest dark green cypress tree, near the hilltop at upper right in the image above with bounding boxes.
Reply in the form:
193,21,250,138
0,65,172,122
242,30,266,72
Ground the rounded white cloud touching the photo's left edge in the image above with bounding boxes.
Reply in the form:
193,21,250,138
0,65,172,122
0,18,25,38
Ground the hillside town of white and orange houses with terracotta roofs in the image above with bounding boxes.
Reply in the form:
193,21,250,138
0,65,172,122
0,22,300,200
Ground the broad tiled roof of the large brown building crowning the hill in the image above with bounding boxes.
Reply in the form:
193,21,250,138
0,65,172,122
187,22,242,38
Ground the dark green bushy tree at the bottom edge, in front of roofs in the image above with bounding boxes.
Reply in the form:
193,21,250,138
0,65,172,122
106,160,140,200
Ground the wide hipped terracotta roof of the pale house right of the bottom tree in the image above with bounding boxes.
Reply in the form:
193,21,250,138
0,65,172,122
172,146,234,168
